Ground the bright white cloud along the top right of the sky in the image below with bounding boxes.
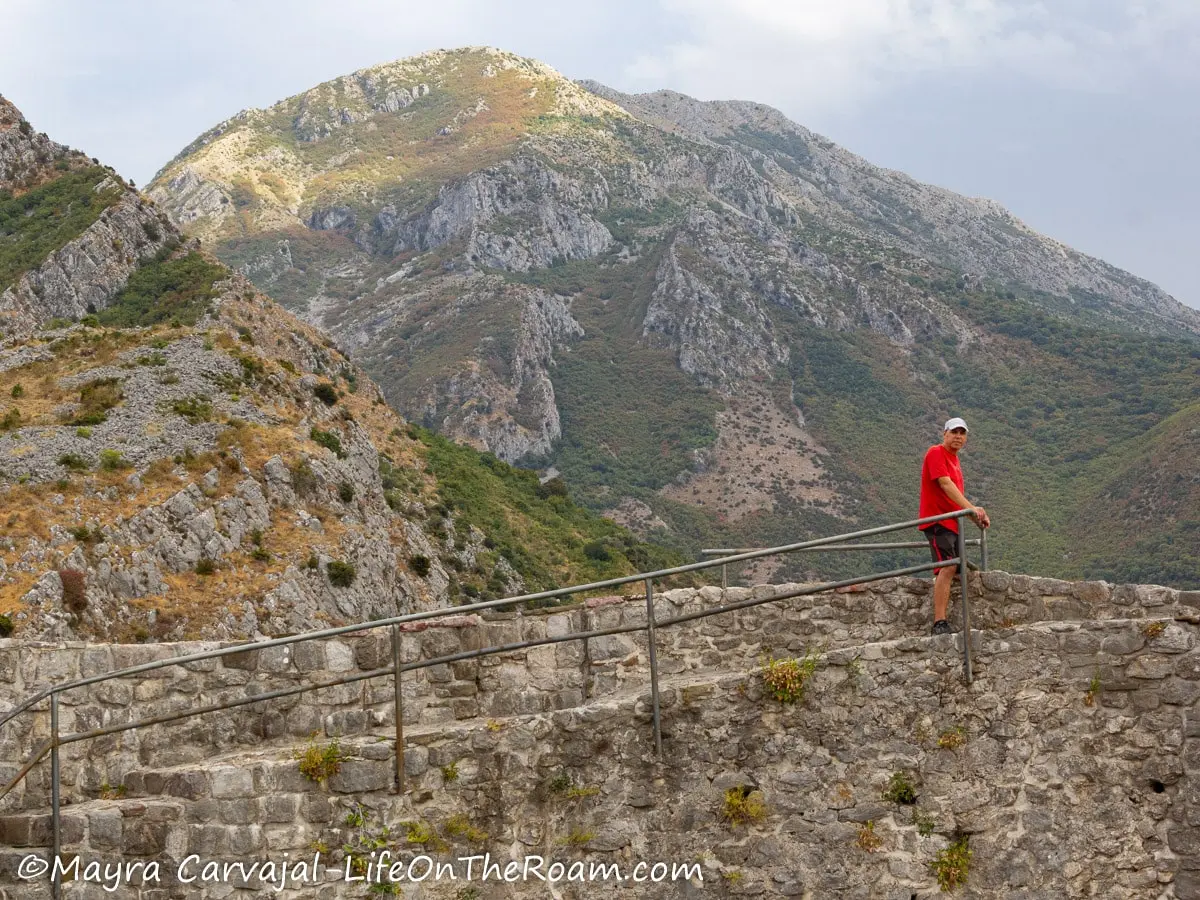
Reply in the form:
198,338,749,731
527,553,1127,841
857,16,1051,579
624,0,1200,115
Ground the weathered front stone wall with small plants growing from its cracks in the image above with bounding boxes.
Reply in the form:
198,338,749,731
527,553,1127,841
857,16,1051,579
0,572,1200,900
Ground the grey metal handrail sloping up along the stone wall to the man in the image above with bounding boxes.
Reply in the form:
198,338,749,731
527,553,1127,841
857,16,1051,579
0,510,986,896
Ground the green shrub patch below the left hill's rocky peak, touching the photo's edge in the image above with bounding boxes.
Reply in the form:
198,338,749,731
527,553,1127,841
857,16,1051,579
0,166,125,292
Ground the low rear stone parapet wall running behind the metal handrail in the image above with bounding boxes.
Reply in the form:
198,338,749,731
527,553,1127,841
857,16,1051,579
0,571,1200,809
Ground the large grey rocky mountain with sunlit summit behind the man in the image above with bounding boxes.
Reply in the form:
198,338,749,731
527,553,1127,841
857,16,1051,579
150,48,1200,580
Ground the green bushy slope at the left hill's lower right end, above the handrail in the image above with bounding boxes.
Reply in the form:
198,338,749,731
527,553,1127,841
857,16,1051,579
412,426,684,599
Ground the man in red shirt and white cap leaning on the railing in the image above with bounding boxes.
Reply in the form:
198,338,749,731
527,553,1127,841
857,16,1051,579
920,418,991,635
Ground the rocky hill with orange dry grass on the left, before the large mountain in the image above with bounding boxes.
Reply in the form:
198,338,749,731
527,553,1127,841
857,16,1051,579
0,98,662,641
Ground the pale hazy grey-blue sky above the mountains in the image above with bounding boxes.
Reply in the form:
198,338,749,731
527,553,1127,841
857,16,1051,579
0,0,1200,307
